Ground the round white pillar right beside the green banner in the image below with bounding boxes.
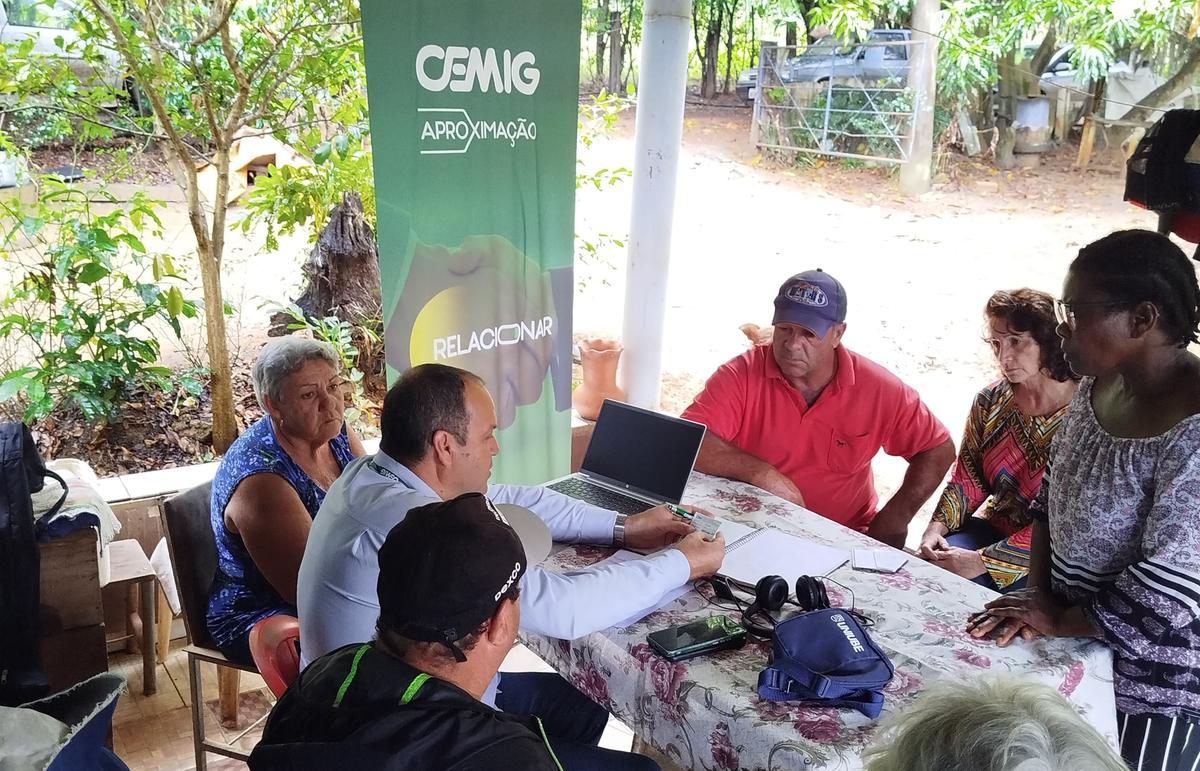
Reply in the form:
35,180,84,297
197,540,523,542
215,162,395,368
620,0,691,408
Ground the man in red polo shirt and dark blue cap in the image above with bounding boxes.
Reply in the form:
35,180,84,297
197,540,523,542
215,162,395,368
683,270,954,548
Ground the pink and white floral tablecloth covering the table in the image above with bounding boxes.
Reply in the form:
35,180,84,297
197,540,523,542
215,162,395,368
523,473,1116,771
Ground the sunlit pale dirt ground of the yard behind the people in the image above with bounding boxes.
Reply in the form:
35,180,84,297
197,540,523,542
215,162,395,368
23,104,1153,530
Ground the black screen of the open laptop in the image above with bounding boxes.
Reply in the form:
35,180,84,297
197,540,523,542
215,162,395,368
580,399,704,503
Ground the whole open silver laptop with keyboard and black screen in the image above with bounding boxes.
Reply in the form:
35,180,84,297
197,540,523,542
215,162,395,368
546,399,704,514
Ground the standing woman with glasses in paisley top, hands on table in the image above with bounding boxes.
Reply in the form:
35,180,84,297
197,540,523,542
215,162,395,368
968,231,1200,771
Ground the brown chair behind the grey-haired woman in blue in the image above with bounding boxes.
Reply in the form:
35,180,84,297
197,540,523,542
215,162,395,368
162,483,256,771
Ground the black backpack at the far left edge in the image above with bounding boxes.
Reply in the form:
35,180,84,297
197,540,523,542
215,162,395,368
0,423,67,706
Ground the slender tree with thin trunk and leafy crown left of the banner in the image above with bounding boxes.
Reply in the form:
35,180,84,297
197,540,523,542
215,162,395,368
0,0,366,453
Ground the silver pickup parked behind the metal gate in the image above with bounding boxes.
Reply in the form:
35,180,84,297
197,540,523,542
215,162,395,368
737,30,912,101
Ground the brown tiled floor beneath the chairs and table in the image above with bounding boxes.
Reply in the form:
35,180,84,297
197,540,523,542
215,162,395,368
108,640,634,771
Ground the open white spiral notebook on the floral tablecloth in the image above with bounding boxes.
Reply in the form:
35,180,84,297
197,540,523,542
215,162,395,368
720,520,850,586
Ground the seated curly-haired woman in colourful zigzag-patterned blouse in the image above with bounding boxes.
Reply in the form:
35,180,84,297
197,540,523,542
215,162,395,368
920,289,1079,590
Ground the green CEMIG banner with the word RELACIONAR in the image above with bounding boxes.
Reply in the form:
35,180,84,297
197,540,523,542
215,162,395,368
362,0,581,484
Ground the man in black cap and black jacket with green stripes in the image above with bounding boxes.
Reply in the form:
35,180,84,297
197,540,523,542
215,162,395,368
250,492,658,771
